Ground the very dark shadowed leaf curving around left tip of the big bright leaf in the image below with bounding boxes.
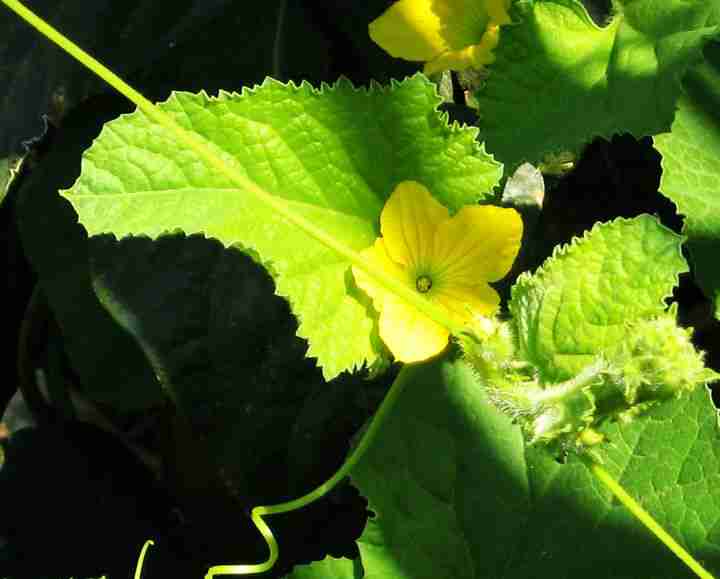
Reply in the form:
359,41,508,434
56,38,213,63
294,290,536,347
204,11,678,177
17,104,163,411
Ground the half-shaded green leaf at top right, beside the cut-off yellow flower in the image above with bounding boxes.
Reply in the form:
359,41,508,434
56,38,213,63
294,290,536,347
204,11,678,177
477,0,718,166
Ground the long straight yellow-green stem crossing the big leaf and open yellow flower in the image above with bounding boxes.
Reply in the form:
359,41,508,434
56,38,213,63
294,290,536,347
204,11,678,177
0,0,461,335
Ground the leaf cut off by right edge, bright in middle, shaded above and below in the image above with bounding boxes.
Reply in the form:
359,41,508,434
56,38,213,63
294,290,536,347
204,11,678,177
654,44,720,318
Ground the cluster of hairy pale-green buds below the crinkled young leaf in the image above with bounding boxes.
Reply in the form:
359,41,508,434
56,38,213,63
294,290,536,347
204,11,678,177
459,308,720,452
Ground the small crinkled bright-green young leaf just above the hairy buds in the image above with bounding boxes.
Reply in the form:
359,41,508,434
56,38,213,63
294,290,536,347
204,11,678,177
510,215,687,380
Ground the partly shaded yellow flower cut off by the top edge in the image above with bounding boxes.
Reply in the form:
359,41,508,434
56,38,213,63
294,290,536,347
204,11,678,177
369,0,511,74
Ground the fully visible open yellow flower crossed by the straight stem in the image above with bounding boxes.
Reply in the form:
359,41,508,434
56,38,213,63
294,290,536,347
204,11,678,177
353,181,522,362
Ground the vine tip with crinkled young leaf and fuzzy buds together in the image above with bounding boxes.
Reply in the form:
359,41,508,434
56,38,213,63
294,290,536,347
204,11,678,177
486,215,718,451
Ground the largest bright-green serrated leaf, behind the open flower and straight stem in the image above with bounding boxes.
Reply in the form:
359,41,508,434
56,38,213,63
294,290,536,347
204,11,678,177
64,75,500,378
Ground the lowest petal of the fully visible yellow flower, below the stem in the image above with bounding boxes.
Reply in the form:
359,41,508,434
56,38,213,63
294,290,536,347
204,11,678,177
379,299,450,362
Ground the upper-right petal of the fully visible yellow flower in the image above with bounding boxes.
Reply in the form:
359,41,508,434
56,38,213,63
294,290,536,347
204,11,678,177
433,205,523,287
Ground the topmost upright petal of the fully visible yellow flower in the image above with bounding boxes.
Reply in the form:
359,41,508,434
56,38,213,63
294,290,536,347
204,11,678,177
380,181,450,269
